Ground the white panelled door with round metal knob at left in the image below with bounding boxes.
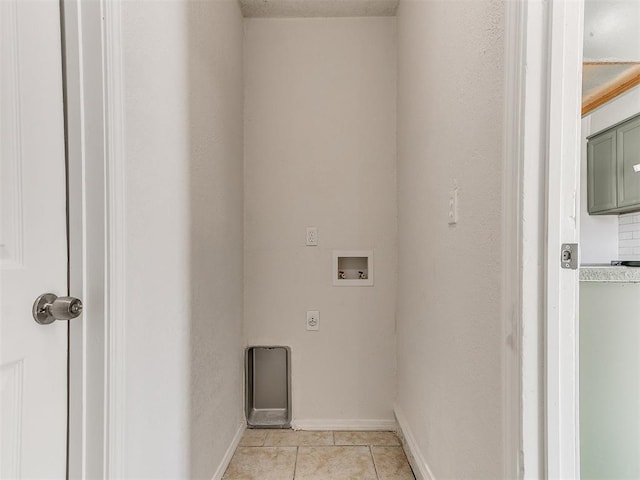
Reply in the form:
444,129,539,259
0,0,67,479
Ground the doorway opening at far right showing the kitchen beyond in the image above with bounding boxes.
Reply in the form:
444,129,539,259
577,0,640,478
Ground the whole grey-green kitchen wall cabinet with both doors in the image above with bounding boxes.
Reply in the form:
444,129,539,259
587,115,640,215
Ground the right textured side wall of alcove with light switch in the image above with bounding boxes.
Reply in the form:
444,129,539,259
396,0,504,478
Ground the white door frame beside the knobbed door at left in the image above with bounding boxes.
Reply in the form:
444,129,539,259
60,0,126,478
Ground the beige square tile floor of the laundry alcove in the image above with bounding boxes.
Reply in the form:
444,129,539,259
223,430,415,480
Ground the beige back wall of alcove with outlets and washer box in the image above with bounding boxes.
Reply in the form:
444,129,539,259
244,18,397,428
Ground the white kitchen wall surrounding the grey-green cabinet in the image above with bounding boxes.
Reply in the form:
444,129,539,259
580,87,640,264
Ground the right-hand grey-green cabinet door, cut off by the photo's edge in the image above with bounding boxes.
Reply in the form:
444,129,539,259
617,118,640,207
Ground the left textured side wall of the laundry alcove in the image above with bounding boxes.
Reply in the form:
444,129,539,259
122,0,243,479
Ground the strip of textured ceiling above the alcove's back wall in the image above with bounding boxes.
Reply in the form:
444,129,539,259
240,0,399,17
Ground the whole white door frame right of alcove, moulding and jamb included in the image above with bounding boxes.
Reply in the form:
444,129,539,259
505,0,584,479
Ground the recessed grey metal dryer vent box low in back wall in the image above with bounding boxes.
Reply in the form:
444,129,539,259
245,347,291,428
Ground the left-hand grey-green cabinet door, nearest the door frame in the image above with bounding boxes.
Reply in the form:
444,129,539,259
587,130,618,213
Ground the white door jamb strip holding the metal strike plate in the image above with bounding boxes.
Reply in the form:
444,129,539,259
545,0,584,479
